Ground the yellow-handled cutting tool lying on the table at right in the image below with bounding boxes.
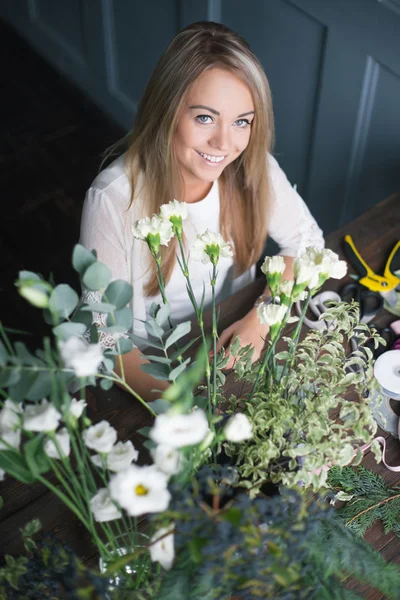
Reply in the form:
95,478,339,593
344,235,400,293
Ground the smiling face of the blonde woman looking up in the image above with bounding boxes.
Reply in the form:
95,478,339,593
174,67,254,202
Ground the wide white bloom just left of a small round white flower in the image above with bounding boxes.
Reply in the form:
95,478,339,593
149,408,209,448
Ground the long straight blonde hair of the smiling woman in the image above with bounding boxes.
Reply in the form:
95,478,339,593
108,21,274,296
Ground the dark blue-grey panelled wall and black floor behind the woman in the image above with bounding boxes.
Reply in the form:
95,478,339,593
0,0,400,338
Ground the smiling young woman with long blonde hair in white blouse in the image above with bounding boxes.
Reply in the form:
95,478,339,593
81,22,323,399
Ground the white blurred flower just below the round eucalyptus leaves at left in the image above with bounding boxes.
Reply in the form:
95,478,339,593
58,336,103,377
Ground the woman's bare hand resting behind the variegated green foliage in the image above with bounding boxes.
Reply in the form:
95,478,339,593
217,308,269,369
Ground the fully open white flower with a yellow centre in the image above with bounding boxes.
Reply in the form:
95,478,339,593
110,465,171,517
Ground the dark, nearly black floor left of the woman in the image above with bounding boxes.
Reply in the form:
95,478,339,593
0,21,124,342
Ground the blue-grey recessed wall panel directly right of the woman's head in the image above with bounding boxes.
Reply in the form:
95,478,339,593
222,0,325,193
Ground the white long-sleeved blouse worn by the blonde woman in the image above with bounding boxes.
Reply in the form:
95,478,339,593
80,155,324,347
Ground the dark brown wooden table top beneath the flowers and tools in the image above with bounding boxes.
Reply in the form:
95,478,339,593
0,193,400,600
